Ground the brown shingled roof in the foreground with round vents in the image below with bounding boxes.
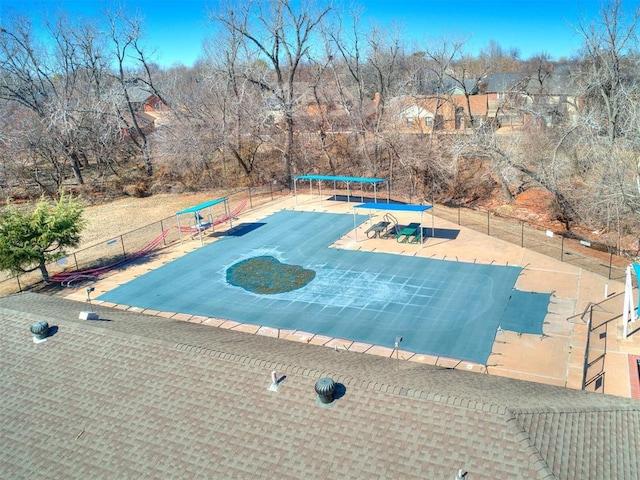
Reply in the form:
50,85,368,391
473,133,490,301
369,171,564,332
5,293,640,480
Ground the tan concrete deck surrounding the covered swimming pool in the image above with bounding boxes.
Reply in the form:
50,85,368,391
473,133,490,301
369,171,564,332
62,195,640,397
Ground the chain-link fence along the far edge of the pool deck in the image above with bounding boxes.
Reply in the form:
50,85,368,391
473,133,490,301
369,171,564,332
0,185,630,294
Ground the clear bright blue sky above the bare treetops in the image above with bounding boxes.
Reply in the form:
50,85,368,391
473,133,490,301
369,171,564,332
0,0,608,66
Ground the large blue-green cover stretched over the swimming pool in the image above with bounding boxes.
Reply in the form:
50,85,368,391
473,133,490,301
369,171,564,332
98,211,548,365
